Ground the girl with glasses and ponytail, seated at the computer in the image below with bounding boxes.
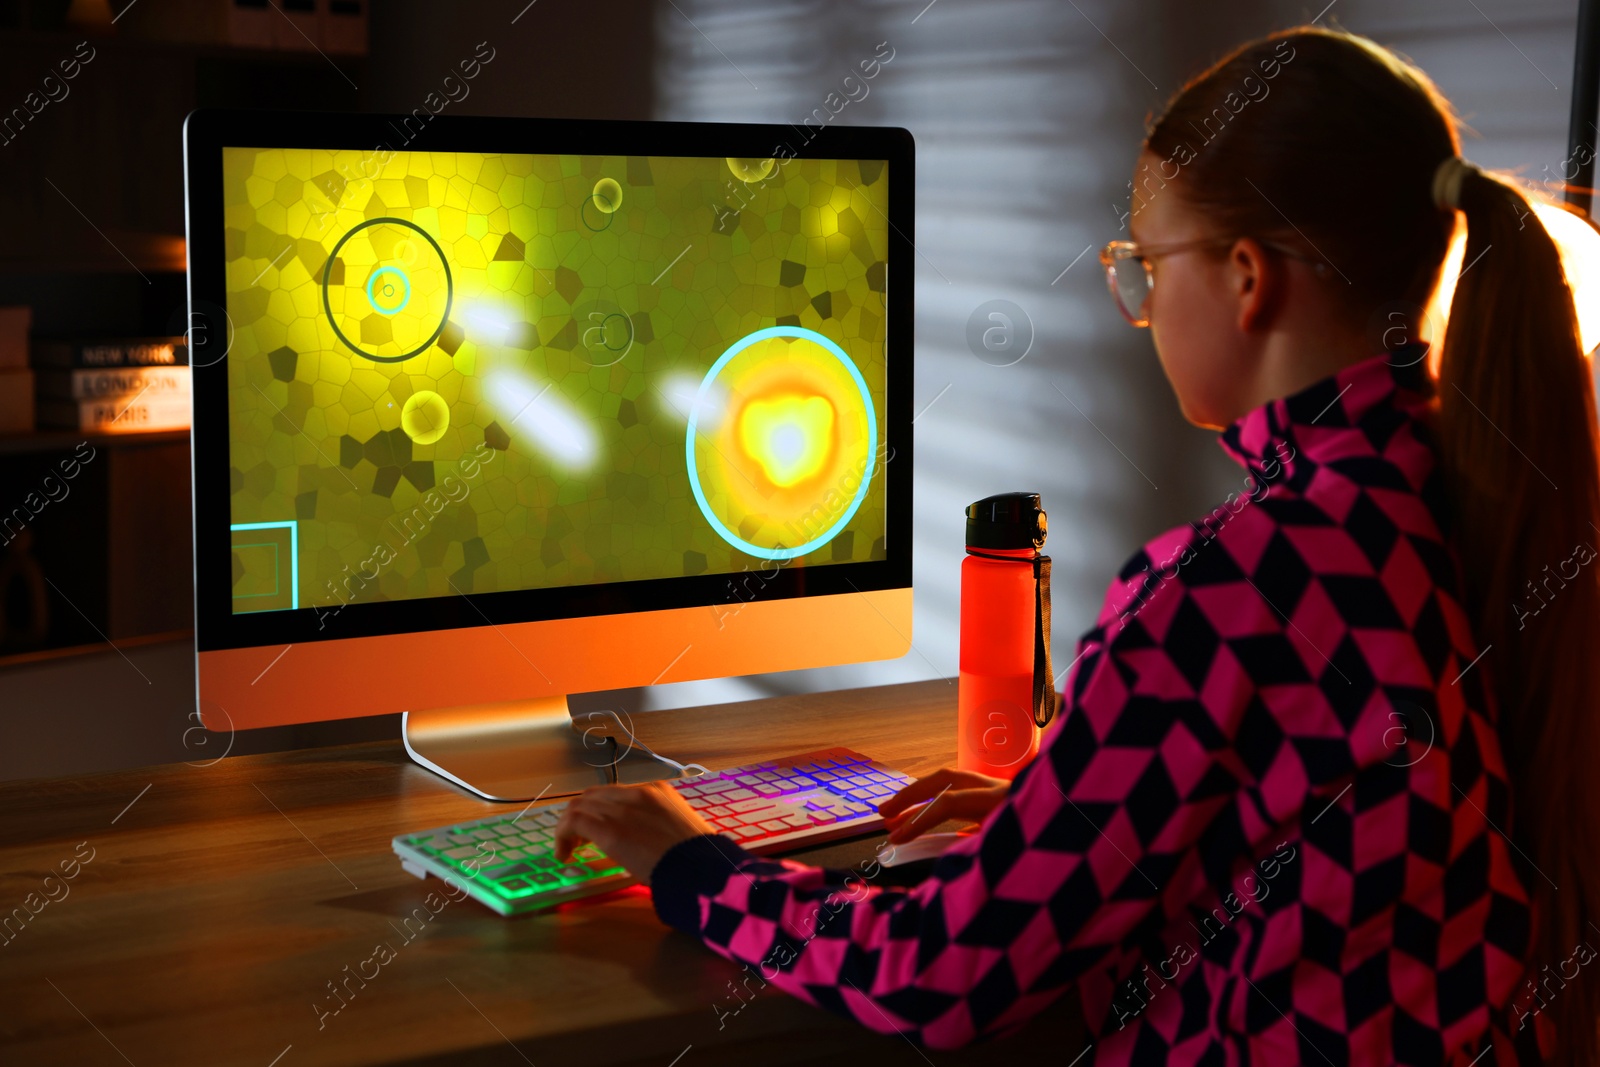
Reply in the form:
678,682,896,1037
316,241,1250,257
558,29,1600,1065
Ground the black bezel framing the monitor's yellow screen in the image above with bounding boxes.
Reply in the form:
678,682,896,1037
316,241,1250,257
184,110,917,653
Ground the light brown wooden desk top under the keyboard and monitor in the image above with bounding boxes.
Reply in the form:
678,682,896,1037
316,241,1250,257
0,681,1086,1067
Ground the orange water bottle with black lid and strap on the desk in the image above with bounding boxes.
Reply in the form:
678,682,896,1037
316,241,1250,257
955,493,1056,779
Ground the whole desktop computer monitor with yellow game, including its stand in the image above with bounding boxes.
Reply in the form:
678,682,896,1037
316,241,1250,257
184,109,915,800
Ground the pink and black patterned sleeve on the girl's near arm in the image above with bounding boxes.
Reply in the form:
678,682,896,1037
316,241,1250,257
651,550,1246,1048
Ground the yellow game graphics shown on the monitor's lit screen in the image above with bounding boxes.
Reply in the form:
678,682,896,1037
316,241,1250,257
222,149,888,613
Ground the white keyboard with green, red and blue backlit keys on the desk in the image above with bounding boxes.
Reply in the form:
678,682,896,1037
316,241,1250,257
394,749,912,915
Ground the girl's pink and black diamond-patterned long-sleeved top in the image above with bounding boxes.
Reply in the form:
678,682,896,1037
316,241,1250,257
653,350,1539,1065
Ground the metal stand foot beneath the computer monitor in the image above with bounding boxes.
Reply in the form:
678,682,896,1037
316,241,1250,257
400,696,677,803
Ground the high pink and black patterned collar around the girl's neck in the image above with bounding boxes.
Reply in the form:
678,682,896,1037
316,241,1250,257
1219,342,1434,475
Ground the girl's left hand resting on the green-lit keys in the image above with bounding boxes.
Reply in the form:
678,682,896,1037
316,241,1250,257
555,782,717,885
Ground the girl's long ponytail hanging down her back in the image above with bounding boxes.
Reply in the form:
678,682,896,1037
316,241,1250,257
1438,166,1600,1064
